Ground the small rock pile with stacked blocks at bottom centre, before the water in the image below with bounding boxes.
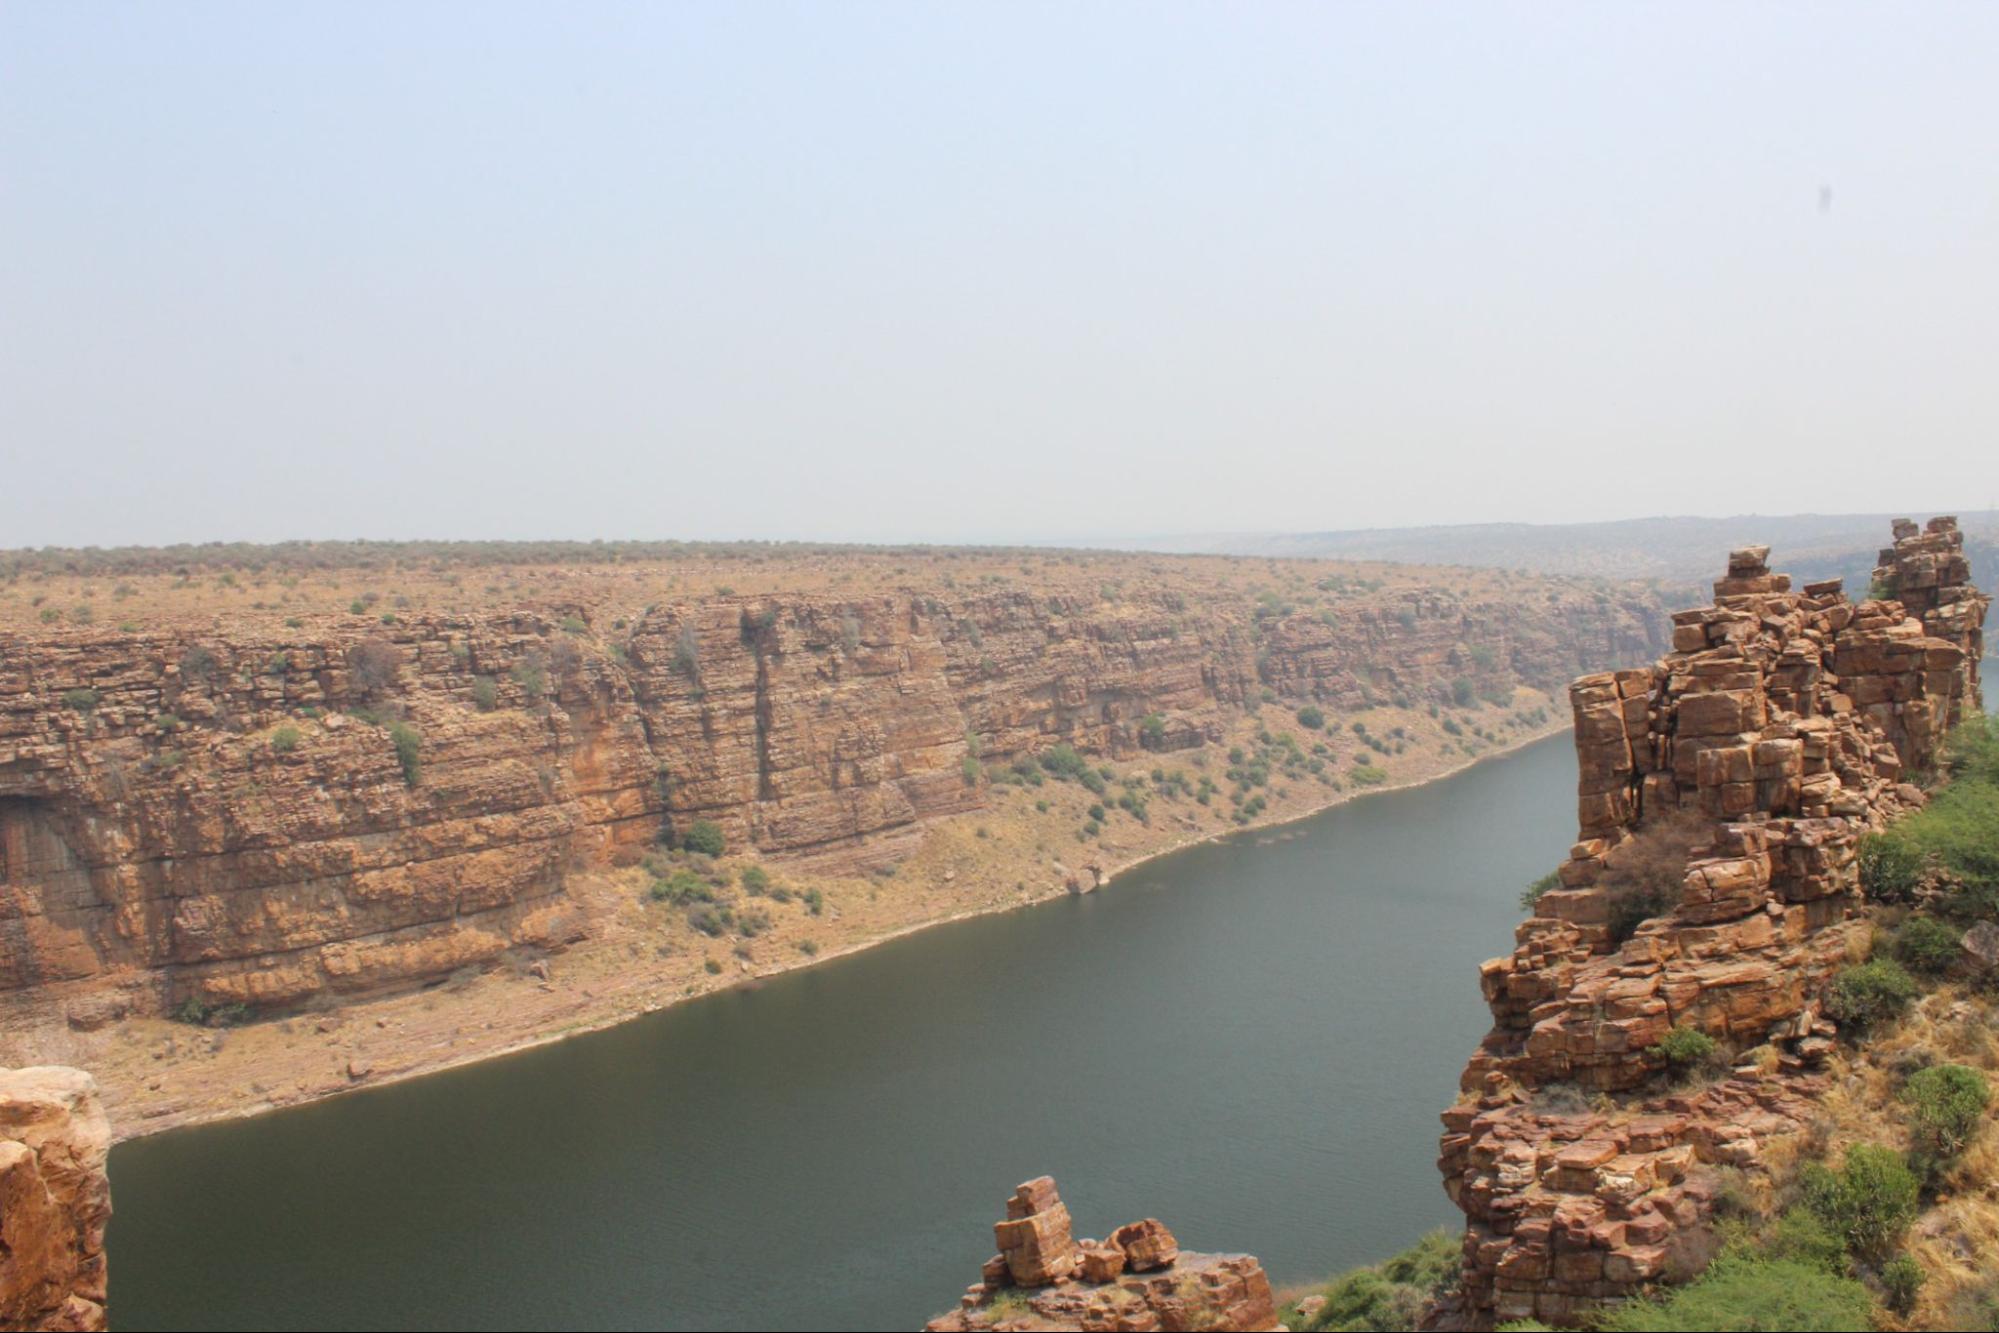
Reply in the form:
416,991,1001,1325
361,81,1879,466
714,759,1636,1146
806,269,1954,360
924,1175,1281,1333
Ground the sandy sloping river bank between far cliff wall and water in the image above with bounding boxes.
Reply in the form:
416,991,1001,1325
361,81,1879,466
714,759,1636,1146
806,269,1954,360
15,689,1567,1141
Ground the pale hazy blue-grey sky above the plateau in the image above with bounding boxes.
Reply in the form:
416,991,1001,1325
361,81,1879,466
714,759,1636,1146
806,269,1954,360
0,0,1999,546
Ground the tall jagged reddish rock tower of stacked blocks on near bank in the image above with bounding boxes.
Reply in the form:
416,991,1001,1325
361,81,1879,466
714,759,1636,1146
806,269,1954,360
1437,518,1987,1327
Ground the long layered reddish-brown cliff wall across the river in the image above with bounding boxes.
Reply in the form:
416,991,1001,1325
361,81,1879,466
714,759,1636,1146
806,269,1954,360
0,586,1655,1027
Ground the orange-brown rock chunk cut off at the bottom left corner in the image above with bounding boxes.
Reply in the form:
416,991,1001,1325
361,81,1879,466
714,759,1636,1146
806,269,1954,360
0,1065,112,1329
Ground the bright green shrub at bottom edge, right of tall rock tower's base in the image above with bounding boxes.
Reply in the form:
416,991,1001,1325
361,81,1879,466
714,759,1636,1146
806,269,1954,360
1597,1251,1873,1333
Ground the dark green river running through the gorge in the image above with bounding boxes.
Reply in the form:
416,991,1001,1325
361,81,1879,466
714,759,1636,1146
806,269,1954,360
108,735,1575,1329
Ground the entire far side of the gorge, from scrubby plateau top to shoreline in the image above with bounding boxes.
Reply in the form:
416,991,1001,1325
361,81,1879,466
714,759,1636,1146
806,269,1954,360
0,546,1661,1135
